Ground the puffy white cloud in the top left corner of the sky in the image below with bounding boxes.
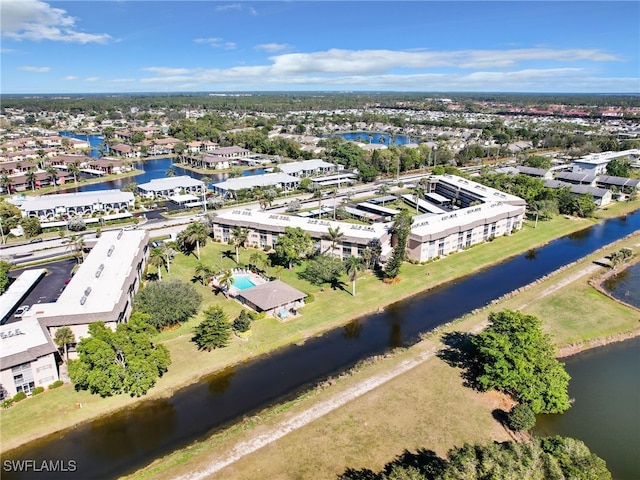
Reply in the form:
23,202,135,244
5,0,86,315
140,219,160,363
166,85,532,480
0,0,111,43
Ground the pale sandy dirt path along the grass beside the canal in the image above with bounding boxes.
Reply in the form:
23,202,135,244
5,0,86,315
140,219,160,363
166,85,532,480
176,348,437,480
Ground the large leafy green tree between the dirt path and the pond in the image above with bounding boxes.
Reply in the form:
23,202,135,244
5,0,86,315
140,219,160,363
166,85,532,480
473,310,570,413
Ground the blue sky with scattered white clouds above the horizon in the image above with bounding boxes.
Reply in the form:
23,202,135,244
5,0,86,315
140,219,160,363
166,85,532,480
0,0,640,93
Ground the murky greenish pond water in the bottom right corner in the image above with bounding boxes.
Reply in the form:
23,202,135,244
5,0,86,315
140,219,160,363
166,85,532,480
534,338,640,480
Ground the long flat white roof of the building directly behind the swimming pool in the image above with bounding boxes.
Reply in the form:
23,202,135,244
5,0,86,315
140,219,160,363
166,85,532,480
215,209,387,240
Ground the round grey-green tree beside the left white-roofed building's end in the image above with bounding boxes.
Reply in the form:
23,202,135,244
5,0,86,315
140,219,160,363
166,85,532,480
133,279,202,329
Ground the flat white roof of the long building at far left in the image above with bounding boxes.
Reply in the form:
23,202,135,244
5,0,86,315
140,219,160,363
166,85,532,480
32,230,146,318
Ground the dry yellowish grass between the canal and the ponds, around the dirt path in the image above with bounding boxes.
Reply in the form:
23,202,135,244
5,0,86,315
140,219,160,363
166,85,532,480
131,214,640,480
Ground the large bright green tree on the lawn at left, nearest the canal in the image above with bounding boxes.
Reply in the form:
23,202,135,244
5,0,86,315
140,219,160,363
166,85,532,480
69,312,171,397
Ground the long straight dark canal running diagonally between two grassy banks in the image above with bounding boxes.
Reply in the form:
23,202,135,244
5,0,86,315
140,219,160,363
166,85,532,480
3,211,640,479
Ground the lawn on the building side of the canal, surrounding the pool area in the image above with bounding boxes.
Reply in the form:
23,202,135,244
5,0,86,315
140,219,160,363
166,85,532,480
0,202,639,451
